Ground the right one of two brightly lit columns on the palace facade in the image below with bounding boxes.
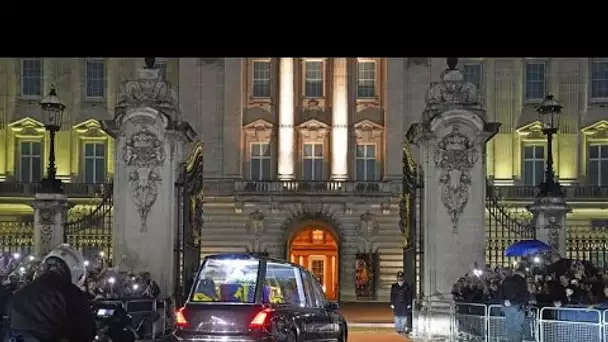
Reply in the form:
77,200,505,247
331,58,348,181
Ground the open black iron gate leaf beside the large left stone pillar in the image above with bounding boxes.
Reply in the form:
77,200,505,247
175,142,203,305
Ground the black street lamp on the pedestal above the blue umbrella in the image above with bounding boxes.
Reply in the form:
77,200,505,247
537,94,564,196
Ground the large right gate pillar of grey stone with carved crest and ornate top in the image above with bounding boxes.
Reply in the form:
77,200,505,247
408,59,500,299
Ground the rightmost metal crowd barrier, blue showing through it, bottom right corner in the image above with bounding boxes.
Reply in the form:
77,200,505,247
539,307,606,342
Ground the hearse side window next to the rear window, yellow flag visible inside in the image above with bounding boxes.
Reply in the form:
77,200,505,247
262,262,306,306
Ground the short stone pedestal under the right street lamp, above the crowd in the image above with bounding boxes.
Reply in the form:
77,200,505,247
527,194,572,257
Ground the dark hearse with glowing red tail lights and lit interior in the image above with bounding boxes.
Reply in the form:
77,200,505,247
173,254,348,342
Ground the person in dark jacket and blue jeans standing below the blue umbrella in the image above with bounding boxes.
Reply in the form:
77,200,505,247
499,265,529,342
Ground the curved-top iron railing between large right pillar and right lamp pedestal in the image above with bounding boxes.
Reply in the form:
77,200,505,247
486,179,536,267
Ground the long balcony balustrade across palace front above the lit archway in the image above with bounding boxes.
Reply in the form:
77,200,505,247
234,181,401,197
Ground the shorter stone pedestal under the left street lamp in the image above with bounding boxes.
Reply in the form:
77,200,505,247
31,193,70,258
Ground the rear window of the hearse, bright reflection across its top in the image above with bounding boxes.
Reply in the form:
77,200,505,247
191,258,260,303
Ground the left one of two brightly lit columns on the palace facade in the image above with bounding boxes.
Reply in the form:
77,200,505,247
279,58,295,180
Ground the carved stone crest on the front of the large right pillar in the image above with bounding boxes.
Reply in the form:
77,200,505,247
435,125,479,232
